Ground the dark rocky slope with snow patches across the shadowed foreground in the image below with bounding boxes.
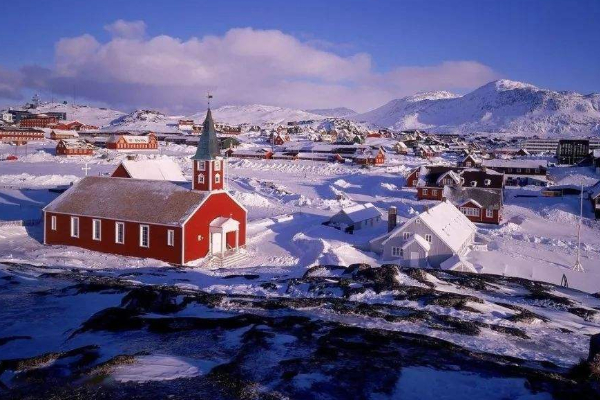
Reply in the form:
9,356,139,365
0,264,600,399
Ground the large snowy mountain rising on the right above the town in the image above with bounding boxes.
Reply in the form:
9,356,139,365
352,80,600,136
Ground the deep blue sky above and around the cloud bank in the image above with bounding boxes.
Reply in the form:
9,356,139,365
0,0,600,108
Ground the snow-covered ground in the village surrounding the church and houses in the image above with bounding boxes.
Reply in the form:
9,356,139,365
0,139,600,292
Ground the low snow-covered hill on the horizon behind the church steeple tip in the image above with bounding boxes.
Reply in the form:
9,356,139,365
190,104,325,125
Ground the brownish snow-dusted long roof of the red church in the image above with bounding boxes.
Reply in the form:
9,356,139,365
45,176,204,225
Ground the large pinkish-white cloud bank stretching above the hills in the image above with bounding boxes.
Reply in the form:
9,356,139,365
3,20,498,112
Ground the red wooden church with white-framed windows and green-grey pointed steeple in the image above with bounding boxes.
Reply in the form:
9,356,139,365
44,109,247,264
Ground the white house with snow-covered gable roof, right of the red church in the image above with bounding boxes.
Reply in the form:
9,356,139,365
369,201,476,268
